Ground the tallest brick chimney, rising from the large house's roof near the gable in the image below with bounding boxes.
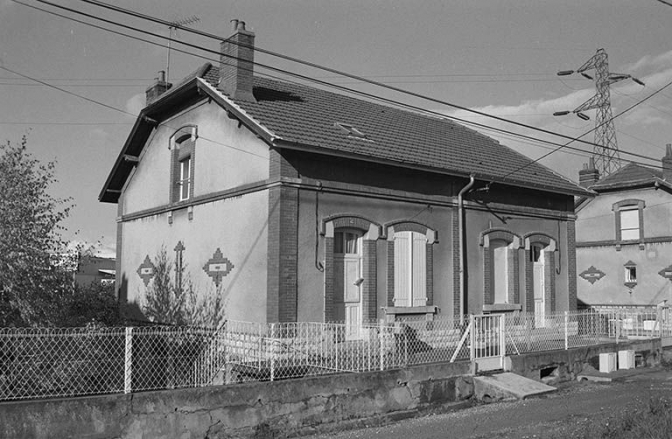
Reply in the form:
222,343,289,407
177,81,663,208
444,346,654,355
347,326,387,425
219,20,257,102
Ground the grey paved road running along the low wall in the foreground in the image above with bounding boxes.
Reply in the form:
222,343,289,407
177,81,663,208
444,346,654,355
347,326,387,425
310,369,672,439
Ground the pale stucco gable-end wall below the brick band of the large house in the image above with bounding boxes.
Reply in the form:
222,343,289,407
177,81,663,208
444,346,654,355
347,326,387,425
118,191,268,323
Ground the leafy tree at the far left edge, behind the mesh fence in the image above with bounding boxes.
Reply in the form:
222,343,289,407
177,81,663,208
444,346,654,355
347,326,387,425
0,136,73,326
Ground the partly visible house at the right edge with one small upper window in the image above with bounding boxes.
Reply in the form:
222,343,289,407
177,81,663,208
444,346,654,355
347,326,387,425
576,150,672,309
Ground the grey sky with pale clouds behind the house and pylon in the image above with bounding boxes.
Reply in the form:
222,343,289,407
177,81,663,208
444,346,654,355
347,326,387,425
0,0,672,253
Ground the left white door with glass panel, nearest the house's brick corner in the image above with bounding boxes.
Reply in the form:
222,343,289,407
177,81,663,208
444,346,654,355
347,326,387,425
334,229,364,340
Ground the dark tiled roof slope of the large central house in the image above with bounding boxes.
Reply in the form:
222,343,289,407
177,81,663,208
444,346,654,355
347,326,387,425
199,66,589,195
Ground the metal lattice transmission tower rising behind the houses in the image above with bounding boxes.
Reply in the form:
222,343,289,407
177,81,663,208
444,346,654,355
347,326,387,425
553,49,644,177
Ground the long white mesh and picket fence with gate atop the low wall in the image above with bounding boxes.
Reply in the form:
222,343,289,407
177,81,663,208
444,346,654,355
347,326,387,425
0,310,672,400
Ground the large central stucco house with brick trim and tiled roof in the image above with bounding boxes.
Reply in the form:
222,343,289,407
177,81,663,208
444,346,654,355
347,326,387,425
100,20,592,325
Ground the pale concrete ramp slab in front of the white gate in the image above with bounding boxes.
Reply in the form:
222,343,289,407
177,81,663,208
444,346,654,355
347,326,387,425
474,372,557,401
